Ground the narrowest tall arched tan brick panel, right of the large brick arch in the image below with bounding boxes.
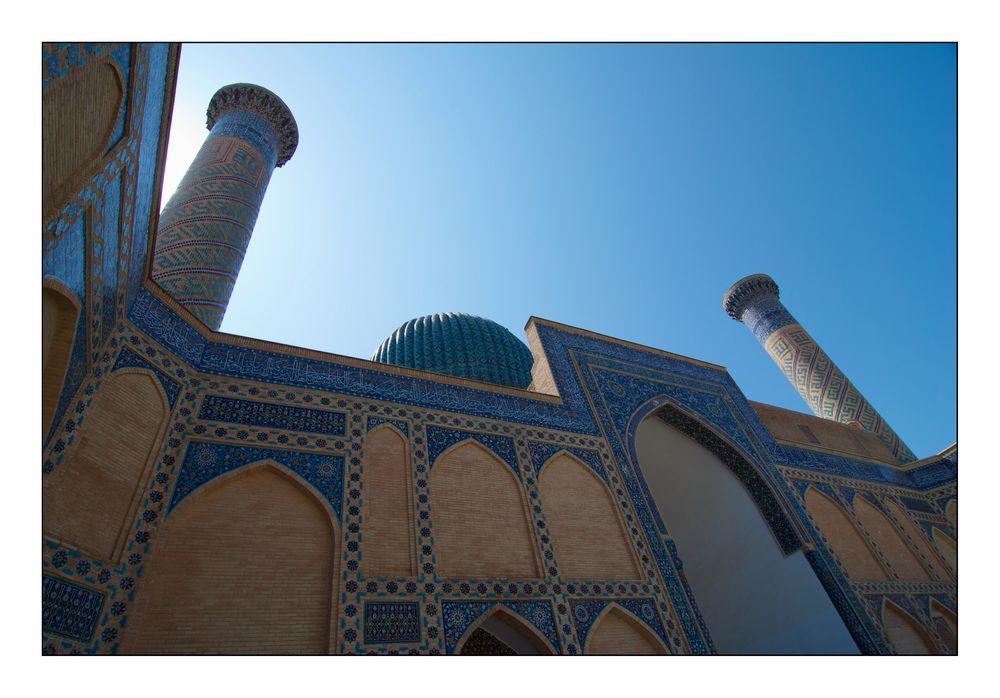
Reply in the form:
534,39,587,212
361,425,415,577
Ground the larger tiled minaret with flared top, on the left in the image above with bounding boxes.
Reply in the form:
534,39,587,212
152,84,299,330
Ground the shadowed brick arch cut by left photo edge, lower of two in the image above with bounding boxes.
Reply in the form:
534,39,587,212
42,284,80,438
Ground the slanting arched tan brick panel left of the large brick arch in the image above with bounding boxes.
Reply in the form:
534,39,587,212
42,372,167,560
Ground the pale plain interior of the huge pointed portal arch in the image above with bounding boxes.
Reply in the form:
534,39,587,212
635,407,858,654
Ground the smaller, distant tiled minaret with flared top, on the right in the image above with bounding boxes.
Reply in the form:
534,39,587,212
722,274,916,463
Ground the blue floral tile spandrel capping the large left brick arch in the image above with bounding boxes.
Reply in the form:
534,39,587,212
167,441,344,521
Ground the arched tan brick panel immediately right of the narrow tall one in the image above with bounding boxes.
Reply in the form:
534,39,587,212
430,441,541,578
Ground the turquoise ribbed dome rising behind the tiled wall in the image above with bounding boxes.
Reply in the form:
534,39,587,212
372,313,532,388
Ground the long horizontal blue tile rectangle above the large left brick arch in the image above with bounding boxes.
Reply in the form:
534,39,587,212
198,395,347,436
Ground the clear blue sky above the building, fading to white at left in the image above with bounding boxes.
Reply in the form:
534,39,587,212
164,44,957,457
